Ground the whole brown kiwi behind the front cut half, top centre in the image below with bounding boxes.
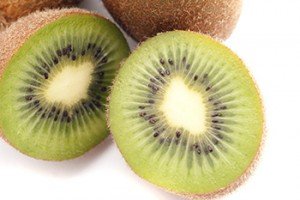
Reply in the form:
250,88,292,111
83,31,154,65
103,0,242,41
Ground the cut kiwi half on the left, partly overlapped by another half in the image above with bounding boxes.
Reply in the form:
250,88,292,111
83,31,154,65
0,8,129,160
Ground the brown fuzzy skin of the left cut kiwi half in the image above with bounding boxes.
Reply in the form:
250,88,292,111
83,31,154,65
0,8,115,160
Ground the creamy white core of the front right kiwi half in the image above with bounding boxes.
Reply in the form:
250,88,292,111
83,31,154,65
160,77,206,135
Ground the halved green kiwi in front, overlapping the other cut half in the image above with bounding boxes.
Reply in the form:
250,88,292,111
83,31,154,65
108,31,264,198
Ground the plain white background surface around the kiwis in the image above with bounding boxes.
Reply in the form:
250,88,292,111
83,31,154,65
0,0,300,200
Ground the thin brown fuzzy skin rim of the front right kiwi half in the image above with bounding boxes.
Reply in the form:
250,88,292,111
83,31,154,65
106,31,267,200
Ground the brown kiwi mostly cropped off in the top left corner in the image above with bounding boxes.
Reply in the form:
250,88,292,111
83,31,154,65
0,0,82,31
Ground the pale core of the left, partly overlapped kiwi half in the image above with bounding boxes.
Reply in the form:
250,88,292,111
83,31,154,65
45,61,94,106
